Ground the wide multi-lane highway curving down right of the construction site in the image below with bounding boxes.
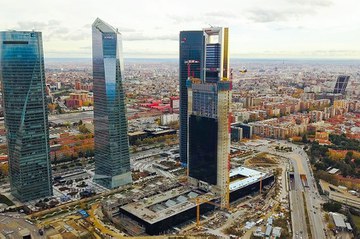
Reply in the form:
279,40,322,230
248,141,326,239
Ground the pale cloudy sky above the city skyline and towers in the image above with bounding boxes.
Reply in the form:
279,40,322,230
0,0,360,59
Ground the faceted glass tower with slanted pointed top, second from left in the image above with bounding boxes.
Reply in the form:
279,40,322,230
92,18,132,188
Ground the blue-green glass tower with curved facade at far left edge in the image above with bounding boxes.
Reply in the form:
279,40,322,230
0,31,52,202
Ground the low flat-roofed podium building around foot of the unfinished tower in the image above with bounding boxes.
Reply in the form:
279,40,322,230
103,167,274,236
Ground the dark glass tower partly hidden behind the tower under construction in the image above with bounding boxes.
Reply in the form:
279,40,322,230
179,31,204,166
